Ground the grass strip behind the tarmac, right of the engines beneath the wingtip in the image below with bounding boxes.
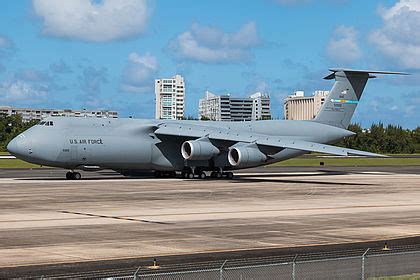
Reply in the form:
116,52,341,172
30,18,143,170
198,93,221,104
271,157,420,166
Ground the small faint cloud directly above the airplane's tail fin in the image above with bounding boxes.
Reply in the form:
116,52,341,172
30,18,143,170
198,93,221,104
326,25,362,63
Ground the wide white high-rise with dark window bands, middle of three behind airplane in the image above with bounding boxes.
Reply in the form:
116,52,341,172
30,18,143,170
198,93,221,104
199,91,271,121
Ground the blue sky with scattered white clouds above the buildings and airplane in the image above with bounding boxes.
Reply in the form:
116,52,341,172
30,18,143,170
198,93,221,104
0,0,420,128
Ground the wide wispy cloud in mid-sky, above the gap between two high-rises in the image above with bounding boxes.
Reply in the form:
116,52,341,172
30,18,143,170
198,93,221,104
169,22,261,63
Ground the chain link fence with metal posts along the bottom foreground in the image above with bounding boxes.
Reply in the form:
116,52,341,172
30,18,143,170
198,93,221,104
104,249,420,280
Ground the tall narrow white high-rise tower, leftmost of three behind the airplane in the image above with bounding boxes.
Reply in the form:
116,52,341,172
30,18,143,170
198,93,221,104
155,75,185,120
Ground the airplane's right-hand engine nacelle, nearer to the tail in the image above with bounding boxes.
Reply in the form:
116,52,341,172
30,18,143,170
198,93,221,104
228,144,267,167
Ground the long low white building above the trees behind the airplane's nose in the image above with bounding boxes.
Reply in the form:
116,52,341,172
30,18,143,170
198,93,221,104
0,106,118,122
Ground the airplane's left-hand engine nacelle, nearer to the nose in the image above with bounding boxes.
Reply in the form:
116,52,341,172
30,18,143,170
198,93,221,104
181,138,220,160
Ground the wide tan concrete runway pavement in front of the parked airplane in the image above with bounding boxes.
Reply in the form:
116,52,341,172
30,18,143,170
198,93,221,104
0,167,420,276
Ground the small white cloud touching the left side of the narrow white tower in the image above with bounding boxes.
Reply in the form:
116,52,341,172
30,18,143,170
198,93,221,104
121,52,159,93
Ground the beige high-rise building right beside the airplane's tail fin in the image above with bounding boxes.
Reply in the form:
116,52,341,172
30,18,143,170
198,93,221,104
284,90,330,120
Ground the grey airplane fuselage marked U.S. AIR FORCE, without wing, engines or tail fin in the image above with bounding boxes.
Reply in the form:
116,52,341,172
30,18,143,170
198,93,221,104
8,117,352,171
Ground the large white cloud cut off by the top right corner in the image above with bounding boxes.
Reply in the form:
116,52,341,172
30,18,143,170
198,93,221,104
369,0,420,69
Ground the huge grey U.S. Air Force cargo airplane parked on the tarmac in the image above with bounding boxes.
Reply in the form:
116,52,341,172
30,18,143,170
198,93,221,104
7,68,407,180
